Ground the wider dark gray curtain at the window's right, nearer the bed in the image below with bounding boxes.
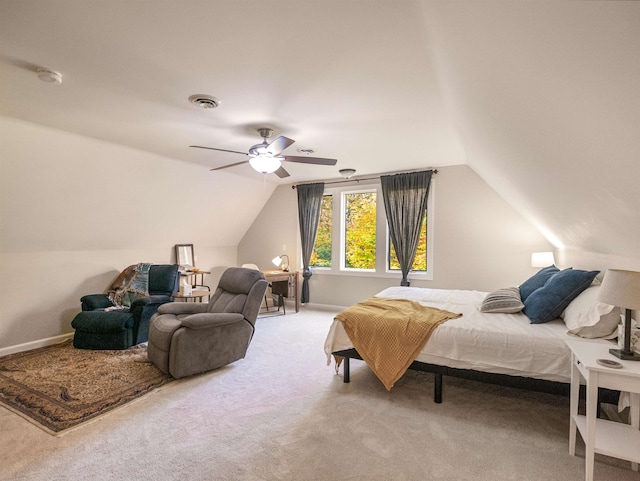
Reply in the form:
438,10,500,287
380,170,433,286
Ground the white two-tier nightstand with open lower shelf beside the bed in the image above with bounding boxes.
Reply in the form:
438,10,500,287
567,337,640,481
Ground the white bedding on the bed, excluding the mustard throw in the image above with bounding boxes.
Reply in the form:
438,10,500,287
324,287,571,383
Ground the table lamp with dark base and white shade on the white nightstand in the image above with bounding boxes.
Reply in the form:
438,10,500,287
598,269,640,361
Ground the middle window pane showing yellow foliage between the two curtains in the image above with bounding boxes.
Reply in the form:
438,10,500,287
344,192,376,269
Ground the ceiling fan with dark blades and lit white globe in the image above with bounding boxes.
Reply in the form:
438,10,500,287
189,128,338,179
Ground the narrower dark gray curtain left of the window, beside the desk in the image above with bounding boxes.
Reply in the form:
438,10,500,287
296,182,324,304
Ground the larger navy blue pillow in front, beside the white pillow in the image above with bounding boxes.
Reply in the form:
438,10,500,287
523,269,600,324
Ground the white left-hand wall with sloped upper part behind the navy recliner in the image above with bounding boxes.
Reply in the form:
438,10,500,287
0,117,273,349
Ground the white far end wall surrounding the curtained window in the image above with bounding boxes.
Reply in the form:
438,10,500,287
238,165,553,306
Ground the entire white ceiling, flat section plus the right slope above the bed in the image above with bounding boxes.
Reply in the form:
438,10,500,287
0,0,640,258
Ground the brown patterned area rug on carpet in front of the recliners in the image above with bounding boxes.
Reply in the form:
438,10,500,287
0,340,173,434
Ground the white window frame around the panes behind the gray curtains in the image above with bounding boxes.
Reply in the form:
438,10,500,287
311,178,435,281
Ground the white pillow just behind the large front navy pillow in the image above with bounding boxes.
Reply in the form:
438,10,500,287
560,285,620,339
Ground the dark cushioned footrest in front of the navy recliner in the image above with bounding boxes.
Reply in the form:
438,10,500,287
71,310,134,349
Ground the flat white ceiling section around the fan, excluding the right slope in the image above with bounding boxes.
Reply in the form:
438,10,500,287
1,0,464,182
